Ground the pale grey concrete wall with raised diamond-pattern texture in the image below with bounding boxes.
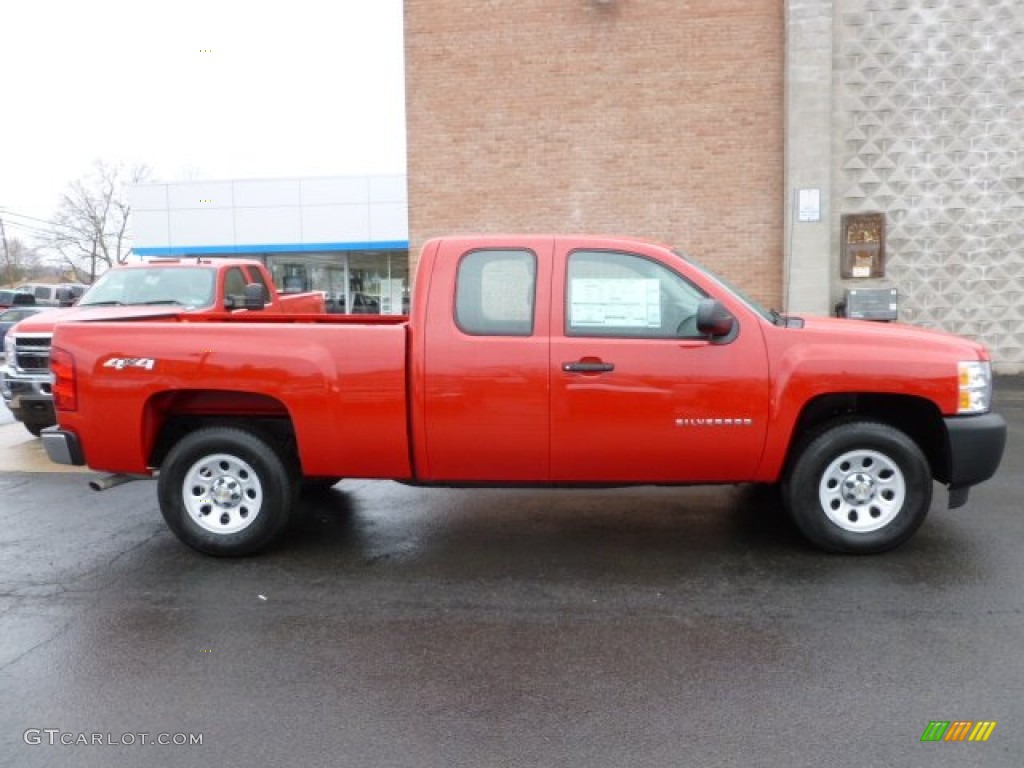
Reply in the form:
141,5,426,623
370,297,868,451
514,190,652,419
821,0,1024,372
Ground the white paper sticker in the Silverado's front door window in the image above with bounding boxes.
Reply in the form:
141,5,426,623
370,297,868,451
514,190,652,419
569,278,662,328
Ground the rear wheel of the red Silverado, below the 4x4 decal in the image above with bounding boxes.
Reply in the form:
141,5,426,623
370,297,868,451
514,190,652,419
157,427,298,557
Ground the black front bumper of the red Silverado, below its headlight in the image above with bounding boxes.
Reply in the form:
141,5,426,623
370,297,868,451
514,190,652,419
945,414,1007,506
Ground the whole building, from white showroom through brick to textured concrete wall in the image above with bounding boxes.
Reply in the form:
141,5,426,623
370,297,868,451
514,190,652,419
132,0,1024,372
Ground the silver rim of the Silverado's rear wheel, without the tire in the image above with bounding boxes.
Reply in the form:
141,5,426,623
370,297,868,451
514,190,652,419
181,454,263,536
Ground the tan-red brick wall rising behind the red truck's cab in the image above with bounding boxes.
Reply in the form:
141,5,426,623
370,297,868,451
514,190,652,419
406,0,784,305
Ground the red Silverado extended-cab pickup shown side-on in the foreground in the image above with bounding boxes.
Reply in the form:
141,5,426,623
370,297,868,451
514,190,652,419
43,236,1006,555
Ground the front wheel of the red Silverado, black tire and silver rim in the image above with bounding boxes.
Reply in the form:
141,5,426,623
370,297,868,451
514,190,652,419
782,421,932,554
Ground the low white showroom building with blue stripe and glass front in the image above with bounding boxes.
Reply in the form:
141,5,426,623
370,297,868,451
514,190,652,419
129,175,410,314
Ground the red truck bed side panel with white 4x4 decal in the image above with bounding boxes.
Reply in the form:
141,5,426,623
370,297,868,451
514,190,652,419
54,313,411,478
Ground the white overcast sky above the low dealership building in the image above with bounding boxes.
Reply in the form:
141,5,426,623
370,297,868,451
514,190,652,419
0,0,406,240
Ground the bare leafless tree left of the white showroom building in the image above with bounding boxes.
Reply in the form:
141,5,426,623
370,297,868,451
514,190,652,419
49,161,151,283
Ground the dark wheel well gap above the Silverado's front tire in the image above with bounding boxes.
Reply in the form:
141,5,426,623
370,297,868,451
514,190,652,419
791,392,949,482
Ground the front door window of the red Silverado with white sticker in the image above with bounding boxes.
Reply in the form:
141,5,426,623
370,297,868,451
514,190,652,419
565,251,705,339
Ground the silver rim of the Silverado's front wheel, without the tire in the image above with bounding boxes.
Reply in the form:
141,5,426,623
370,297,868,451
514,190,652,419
818,450,906,534
